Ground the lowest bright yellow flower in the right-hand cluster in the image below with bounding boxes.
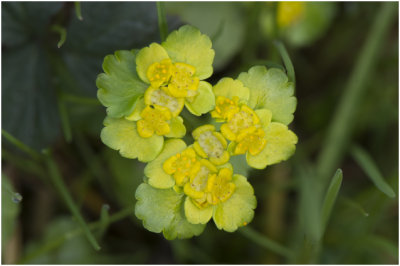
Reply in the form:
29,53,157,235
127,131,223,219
233,126,267,155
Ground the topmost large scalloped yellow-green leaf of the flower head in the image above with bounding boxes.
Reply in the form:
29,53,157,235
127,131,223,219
161,25,215,80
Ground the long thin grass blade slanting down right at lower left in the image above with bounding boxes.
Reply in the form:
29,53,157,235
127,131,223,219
43,149,100,251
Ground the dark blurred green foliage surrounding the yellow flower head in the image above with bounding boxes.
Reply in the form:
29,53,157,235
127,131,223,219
2,2,399,264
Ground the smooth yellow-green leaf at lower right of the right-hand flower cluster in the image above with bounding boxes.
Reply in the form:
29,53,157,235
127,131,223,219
246,122,297,169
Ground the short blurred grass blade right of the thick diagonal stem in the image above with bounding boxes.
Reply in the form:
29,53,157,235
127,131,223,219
350,146,396,198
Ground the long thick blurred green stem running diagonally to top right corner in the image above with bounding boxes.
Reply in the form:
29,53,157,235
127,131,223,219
317,2,397,190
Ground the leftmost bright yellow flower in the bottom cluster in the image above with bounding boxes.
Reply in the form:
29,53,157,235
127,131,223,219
163,147,200,186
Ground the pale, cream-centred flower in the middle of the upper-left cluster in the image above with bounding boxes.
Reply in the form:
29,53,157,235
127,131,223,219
144,87,185,117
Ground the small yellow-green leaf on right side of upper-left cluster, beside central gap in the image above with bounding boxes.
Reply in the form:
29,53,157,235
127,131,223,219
185,81,215,116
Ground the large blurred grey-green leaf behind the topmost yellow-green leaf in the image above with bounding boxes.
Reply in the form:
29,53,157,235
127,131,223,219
166,2,245,70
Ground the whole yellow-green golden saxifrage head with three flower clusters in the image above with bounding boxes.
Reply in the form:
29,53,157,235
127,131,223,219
96,25,297,239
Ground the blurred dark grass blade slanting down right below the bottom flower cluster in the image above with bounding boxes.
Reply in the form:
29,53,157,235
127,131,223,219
238,226,292,257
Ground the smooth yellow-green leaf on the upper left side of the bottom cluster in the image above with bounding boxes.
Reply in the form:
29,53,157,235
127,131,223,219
144,139,186,188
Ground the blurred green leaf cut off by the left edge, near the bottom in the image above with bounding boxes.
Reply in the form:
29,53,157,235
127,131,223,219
1,174,20,249
